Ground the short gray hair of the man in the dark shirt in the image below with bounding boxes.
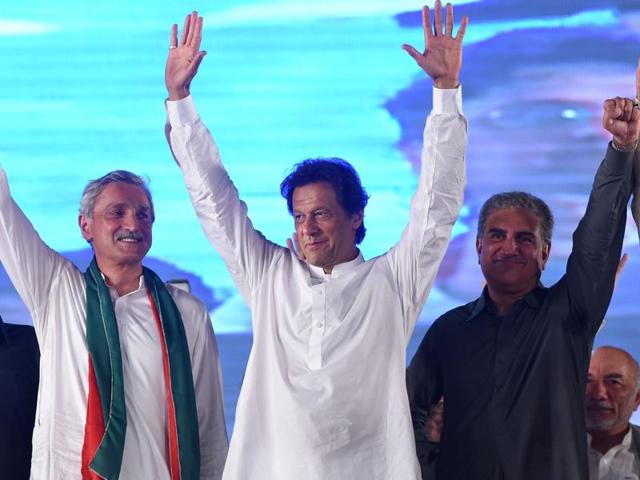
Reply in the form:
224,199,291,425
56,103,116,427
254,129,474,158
478,192,553,244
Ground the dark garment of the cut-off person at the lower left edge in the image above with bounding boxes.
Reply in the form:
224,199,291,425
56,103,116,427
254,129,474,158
0,318,40,480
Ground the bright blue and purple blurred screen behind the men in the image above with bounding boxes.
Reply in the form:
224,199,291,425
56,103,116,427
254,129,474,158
0,0,640,431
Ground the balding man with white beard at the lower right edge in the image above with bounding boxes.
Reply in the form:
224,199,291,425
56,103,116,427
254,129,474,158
585,347,640,480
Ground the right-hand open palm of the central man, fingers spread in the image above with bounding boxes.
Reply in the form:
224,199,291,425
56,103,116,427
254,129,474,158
402,0,469,88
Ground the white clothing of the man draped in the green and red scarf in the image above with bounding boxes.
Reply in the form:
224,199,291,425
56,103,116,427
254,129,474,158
0,169,227,480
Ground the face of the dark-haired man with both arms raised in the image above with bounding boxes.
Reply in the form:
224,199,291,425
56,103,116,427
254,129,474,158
292,182,362,273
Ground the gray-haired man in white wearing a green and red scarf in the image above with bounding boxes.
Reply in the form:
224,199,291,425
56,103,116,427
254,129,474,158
0,169,227,480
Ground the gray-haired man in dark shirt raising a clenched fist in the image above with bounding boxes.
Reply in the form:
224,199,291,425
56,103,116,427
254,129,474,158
407,91,640,480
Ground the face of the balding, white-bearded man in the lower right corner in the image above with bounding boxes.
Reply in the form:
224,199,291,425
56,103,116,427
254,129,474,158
585,347,640,435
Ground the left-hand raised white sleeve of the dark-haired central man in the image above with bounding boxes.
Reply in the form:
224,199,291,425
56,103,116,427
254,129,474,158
166,96,286,305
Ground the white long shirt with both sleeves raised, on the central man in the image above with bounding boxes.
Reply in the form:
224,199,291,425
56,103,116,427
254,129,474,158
167,89,467,480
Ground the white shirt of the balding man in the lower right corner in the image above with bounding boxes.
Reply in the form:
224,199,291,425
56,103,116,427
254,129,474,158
587,429,640,480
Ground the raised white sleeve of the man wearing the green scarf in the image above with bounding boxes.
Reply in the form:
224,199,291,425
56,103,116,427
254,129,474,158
0,168,69,338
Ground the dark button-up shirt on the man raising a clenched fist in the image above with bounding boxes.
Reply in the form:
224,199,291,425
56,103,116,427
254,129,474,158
407,147,632,480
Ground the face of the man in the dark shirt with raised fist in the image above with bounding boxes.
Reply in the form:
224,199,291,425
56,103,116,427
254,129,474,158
476,208,550,294
